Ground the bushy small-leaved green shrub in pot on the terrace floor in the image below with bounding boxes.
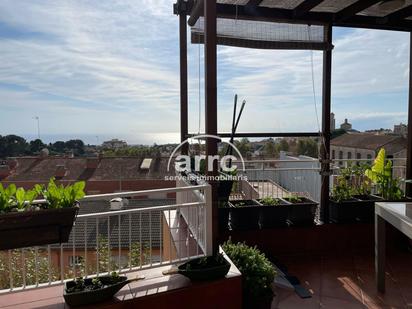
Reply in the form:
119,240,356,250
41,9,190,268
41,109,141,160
222,241,276,309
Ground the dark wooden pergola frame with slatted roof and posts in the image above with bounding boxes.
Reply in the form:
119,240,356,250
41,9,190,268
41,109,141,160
174,0,412,253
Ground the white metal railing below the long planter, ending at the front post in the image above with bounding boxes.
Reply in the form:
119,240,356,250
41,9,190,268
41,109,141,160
0,184,211,293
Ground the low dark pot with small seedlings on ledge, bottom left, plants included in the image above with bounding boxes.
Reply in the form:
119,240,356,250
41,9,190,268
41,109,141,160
63,272,144,307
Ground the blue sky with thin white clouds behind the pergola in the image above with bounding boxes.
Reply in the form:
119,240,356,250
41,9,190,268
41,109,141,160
0,0,409,144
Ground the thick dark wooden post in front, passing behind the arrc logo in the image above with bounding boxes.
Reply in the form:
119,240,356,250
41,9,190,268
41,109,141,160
204,0,218,254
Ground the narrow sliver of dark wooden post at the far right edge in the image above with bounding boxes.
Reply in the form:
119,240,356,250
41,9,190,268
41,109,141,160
405,32,412,196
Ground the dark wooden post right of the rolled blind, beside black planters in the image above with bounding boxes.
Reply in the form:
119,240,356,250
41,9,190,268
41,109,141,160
320,25,332,223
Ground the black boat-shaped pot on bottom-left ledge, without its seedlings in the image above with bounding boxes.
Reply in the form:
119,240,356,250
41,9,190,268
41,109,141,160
63,276,136,307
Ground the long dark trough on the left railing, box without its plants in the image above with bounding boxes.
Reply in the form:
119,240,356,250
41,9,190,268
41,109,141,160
0,206,79,250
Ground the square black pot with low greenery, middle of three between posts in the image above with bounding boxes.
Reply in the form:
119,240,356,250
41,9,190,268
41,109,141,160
257,197,289,229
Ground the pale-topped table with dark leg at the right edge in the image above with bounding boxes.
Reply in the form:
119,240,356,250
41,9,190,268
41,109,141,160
375,202,412,293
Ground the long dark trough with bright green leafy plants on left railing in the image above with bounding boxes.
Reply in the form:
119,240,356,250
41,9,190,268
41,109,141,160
0,179,85,250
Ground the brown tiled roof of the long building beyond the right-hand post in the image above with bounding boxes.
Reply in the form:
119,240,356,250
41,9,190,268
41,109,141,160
331,133,407,154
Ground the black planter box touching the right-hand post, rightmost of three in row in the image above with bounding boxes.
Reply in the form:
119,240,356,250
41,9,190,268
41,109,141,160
284,197,318,226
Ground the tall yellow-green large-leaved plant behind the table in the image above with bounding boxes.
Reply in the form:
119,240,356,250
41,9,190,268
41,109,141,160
365,148,404,200
